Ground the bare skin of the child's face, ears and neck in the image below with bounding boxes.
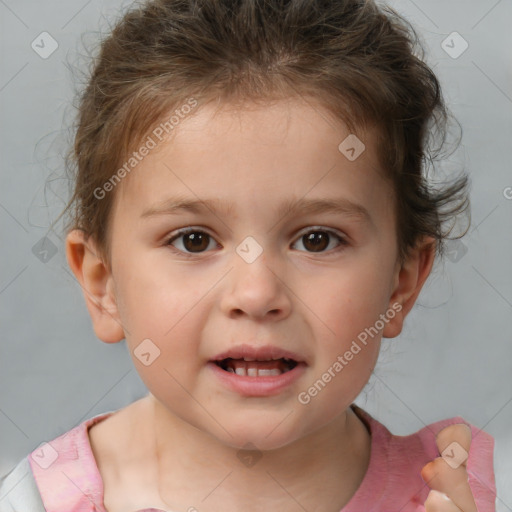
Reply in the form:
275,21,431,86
67,99,474,512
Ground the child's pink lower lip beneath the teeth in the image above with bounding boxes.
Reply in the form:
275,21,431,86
206,361,306,396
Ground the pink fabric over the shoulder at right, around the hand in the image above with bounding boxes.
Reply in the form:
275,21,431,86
344,406,496,512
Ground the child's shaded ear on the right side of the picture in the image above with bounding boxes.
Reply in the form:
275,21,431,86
382,237,436,338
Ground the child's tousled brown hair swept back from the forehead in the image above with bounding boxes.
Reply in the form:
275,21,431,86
61,0,469,264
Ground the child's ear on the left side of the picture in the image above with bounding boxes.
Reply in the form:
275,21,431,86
66,229,124,343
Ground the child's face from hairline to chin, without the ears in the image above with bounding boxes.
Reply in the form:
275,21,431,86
80,96,416,449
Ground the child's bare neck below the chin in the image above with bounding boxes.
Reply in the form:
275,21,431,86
150,395,371,512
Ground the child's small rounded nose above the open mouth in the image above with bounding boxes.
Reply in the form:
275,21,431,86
221,247,291,320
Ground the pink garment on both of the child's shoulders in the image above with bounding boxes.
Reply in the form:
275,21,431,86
28,405,496,512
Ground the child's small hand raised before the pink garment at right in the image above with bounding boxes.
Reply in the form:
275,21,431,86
421,423,478,512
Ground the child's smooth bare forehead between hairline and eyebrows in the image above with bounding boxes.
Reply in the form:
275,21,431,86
111,100,390,227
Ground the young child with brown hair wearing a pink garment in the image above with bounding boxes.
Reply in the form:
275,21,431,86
0,0,496,512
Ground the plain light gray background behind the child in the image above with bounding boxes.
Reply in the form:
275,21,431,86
0,0,512,511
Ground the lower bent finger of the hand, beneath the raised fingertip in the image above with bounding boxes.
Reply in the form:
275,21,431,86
421,457,478,512
